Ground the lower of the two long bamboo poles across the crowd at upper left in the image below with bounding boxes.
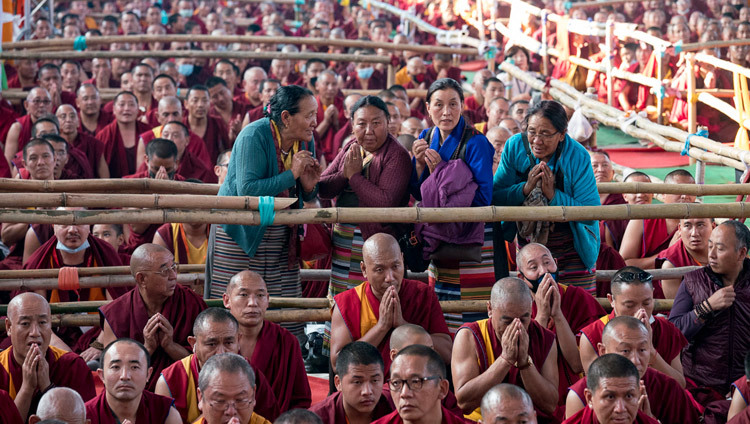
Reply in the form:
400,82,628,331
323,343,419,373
0,50,391,64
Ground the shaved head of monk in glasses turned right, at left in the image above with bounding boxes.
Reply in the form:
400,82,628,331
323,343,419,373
130,243,178,308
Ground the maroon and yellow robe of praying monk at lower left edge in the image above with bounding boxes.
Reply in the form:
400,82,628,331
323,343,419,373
0,346,96,415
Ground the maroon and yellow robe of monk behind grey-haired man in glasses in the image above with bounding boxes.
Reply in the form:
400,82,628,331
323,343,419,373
161,354,279,423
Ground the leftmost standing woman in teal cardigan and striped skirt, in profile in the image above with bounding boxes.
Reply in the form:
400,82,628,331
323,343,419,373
206,86,321,331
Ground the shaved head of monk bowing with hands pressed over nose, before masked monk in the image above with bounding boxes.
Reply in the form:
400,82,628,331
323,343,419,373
487,277,533,340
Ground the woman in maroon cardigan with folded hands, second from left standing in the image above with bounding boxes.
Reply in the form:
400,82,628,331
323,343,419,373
319,96,411,296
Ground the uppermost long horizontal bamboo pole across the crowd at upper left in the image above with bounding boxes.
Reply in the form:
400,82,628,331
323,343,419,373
3,34,477,56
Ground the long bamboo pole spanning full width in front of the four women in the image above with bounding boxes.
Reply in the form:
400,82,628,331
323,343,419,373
0,202,750,225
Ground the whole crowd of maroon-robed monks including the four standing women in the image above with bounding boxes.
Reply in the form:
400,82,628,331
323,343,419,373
0,0,750,424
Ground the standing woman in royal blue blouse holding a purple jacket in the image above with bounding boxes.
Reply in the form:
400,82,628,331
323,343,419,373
410,78,495,333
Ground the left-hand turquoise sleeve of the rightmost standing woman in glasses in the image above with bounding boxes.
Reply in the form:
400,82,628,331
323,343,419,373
492,134,528,206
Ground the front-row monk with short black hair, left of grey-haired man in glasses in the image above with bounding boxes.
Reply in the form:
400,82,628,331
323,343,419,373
86,339,182,424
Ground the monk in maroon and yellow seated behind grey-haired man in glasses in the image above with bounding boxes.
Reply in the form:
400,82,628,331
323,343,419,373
154,308,279,423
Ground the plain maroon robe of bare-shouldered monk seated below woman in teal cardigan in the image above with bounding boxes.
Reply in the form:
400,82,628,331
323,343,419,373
250,320,312,411
